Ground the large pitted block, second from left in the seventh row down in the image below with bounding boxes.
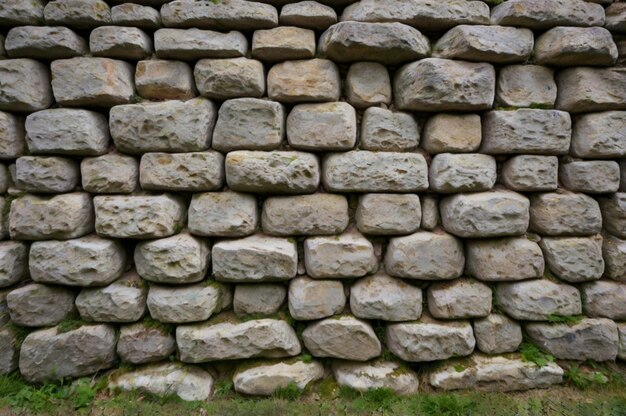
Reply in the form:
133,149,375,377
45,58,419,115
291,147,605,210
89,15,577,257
29,235,127,287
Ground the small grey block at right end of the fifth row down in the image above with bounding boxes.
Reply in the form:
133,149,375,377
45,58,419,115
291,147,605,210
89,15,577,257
559,160,620,194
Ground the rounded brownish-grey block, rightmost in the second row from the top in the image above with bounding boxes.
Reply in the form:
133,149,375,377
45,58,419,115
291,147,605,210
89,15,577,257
535,26,618,66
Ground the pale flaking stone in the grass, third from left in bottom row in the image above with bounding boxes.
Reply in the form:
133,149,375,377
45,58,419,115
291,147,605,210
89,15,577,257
332,359,419,395
